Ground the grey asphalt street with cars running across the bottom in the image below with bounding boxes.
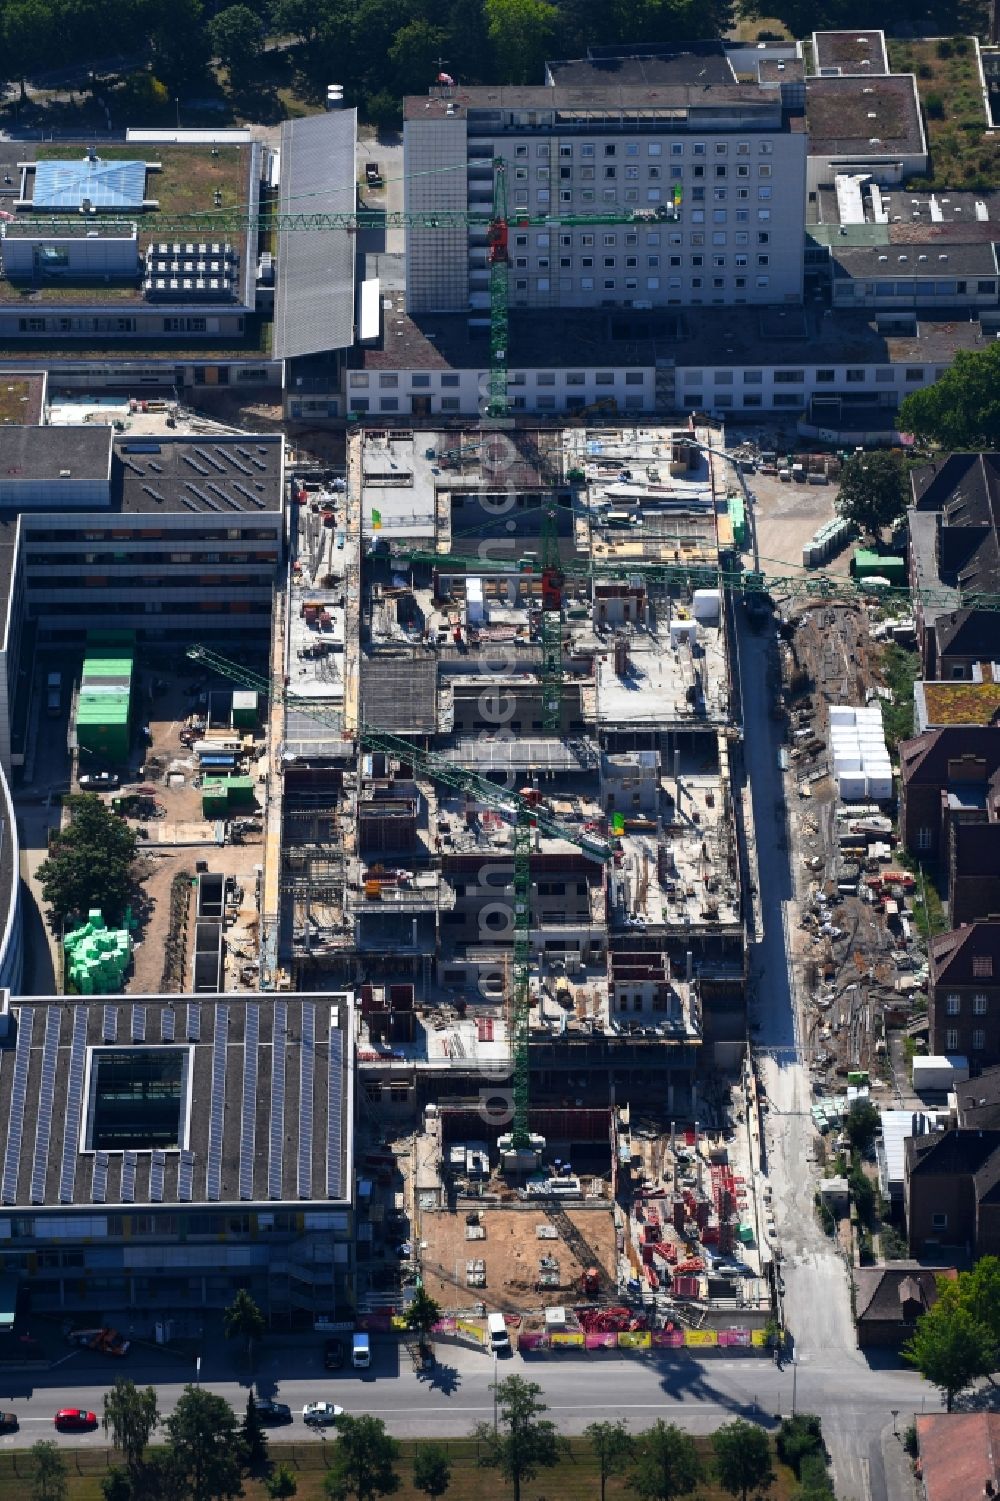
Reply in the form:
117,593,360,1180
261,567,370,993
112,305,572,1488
0,1339,920,1452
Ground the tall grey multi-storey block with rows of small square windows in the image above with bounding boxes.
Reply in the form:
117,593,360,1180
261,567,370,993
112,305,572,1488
404,83,806,315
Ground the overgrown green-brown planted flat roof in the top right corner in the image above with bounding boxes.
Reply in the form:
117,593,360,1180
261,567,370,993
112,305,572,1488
887,36,1000,189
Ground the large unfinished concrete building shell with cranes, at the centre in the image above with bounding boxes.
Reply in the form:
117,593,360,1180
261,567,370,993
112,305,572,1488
180,425,761,1333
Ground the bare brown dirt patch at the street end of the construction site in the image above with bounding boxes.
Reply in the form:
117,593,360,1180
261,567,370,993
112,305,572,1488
420,1204,616,1313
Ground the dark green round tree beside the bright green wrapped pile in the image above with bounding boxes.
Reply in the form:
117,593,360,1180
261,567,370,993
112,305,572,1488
38,793,137,923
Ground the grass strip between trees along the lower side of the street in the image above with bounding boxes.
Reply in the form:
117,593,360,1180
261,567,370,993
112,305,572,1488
0,1438,797,1501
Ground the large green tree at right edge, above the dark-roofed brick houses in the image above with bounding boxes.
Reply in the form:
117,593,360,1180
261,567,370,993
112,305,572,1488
898,342,1000,450
